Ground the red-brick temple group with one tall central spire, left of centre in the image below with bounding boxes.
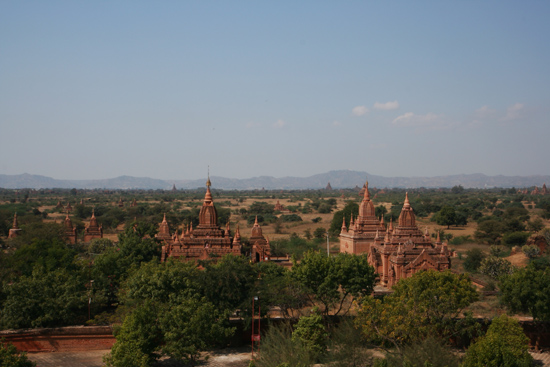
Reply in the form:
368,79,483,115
156,179,271,262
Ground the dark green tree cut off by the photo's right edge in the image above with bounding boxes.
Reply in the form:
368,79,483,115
500,264,550,321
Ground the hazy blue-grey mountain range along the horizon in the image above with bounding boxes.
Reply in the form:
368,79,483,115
0,170,550,190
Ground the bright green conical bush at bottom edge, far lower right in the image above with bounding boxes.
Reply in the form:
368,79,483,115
463,315,533,367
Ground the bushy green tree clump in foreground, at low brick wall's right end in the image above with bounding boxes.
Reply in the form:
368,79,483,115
104,295,234,367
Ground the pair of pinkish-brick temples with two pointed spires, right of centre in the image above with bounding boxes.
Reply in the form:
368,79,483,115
340,182,451,287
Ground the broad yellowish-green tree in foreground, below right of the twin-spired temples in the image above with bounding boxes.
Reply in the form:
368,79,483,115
357,270,478,349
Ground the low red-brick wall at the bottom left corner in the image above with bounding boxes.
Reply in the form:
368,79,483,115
0,326,115,353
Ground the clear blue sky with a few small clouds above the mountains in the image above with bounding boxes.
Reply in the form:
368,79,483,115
0,0,550,180
